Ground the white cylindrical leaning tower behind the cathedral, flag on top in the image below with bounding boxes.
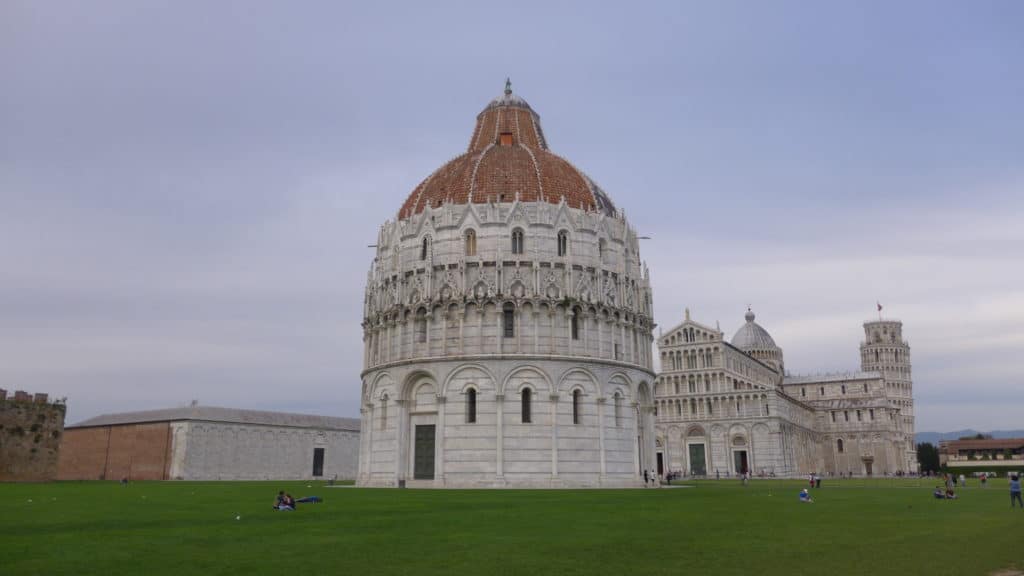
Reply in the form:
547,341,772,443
860,319,918,471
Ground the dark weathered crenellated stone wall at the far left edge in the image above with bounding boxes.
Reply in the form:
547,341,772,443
0,390,66,482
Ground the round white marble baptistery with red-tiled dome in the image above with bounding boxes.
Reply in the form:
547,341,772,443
357,83,654,488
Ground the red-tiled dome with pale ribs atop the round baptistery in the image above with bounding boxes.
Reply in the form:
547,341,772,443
398,82,615,219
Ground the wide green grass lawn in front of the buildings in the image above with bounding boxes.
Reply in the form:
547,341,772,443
0,479,1024,576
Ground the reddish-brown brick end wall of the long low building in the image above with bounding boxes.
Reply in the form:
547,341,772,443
57,422,170,480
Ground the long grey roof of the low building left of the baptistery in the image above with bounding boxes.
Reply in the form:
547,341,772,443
68,406,359,431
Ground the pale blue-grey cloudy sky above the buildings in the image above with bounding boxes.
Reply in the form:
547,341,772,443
0,0,1024,430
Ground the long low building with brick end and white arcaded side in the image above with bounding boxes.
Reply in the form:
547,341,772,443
57,406,359,480
